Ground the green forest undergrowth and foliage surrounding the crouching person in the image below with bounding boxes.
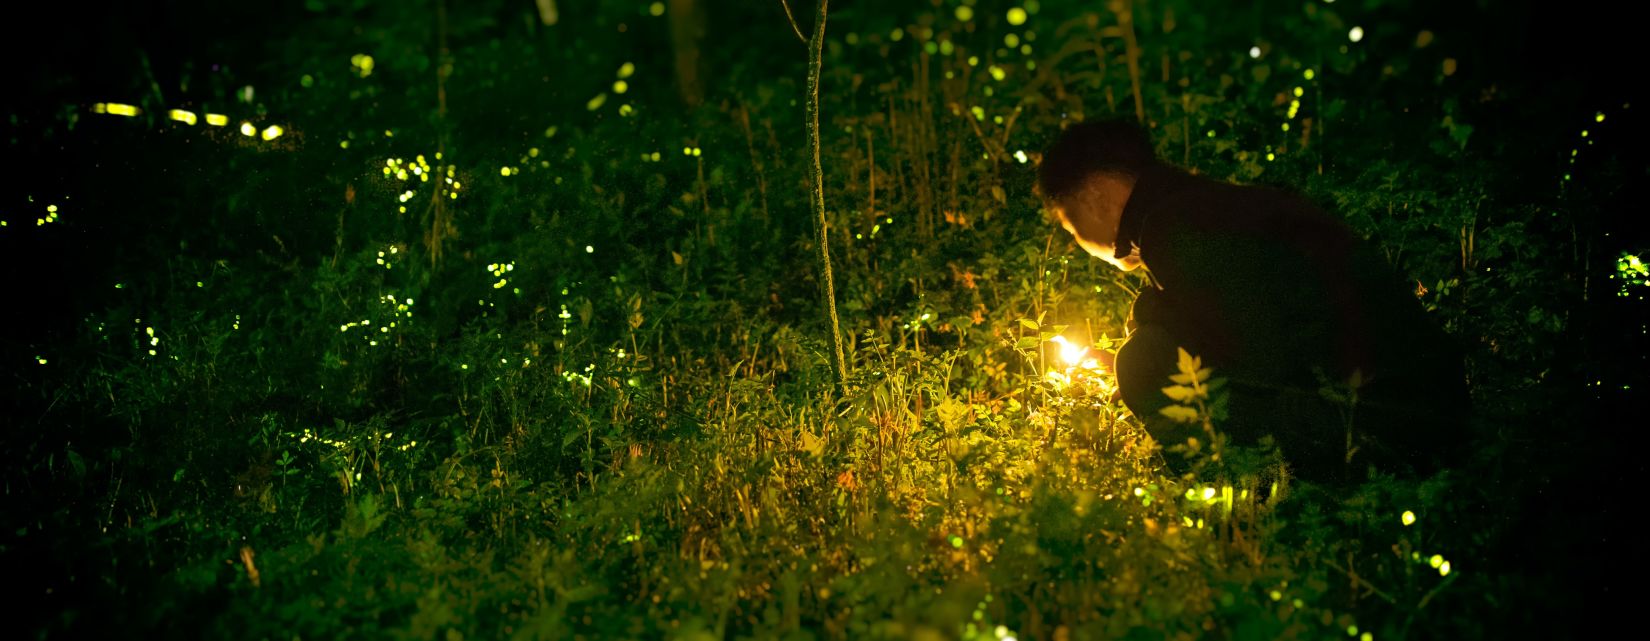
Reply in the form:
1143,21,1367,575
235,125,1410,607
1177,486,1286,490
0,0,1610,639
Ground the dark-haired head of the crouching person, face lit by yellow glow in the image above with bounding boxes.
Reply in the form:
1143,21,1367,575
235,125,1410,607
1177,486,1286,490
1038,121,1157,271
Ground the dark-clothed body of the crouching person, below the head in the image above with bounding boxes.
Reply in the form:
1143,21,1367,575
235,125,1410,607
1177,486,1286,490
1117,167,1467,479
